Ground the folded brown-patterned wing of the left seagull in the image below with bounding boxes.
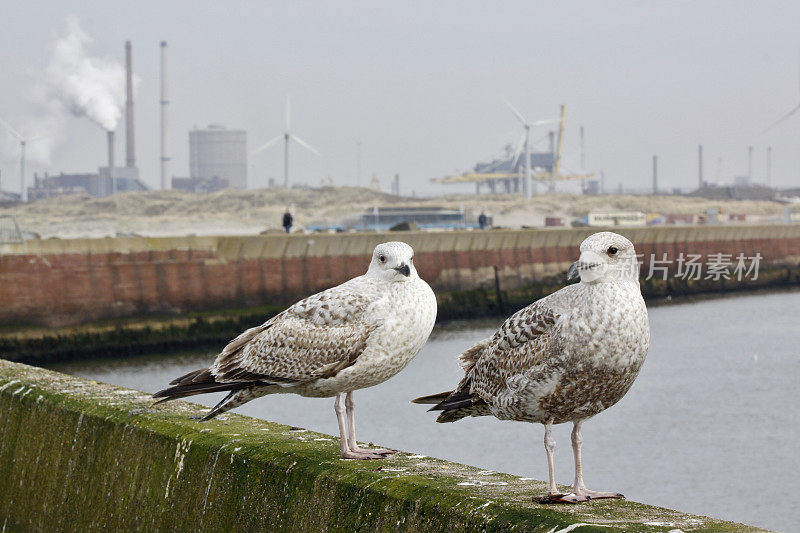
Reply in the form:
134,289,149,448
209,284,379,385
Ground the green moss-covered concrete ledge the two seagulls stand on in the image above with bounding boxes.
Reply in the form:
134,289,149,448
0,360,760,533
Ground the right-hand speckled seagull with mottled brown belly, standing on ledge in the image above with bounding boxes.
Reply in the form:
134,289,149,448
413,232,650,503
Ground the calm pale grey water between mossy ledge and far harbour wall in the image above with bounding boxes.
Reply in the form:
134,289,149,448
53,292,800,531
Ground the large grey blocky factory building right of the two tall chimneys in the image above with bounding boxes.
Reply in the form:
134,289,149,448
189,124,247,189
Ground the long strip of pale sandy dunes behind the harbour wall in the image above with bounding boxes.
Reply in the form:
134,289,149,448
0,187,783,238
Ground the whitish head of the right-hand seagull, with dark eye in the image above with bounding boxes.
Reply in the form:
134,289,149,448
567,231,639,283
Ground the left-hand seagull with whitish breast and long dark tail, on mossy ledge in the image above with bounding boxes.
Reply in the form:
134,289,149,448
153,242,436,459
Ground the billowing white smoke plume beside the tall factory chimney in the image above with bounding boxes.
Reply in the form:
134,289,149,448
45,15,125,130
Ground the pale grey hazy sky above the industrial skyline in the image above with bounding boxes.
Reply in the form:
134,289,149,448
0,0,800,195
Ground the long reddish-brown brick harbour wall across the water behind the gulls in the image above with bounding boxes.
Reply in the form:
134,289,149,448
0,230,800,325
